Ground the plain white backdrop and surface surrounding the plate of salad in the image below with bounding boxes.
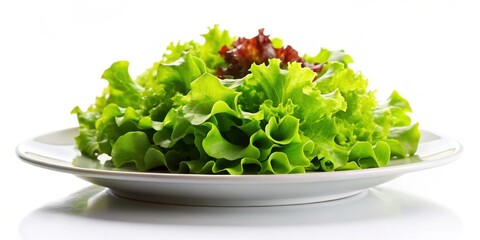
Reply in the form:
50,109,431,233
0,0,480,239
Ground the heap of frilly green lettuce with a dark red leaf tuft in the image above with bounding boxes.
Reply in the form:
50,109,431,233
72,26,420,175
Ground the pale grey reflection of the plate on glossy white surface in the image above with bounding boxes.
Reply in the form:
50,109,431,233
20,186,461,239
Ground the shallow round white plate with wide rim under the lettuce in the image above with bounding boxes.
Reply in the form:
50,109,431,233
16,128,462,206
